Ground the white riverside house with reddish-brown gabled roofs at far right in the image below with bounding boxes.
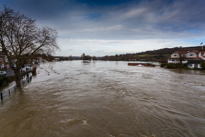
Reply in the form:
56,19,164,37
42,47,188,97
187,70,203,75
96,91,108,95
168,50,205,69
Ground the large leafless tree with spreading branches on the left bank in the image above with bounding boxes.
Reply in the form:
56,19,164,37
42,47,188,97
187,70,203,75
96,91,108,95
0,6,59,84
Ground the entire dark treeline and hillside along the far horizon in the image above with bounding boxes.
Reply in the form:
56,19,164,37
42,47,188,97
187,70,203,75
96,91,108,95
53,46,205,62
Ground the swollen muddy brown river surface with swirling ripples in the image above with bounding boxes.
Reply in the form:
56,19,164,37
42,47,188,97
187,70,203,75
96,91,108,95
0,61,205,137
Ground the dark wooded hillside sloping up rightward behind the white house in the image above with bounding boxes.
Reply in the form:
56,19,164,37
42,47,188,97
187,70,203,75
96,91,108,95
101,46,202,62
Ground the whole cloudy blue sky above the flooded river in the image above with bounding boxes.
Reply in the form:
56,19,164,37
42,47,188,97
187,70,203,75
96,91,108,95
0,0,205,56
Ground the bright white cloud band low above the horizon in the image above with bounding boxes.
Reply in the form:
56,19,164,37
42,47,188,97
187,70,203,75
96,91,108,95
56,39,194,56
